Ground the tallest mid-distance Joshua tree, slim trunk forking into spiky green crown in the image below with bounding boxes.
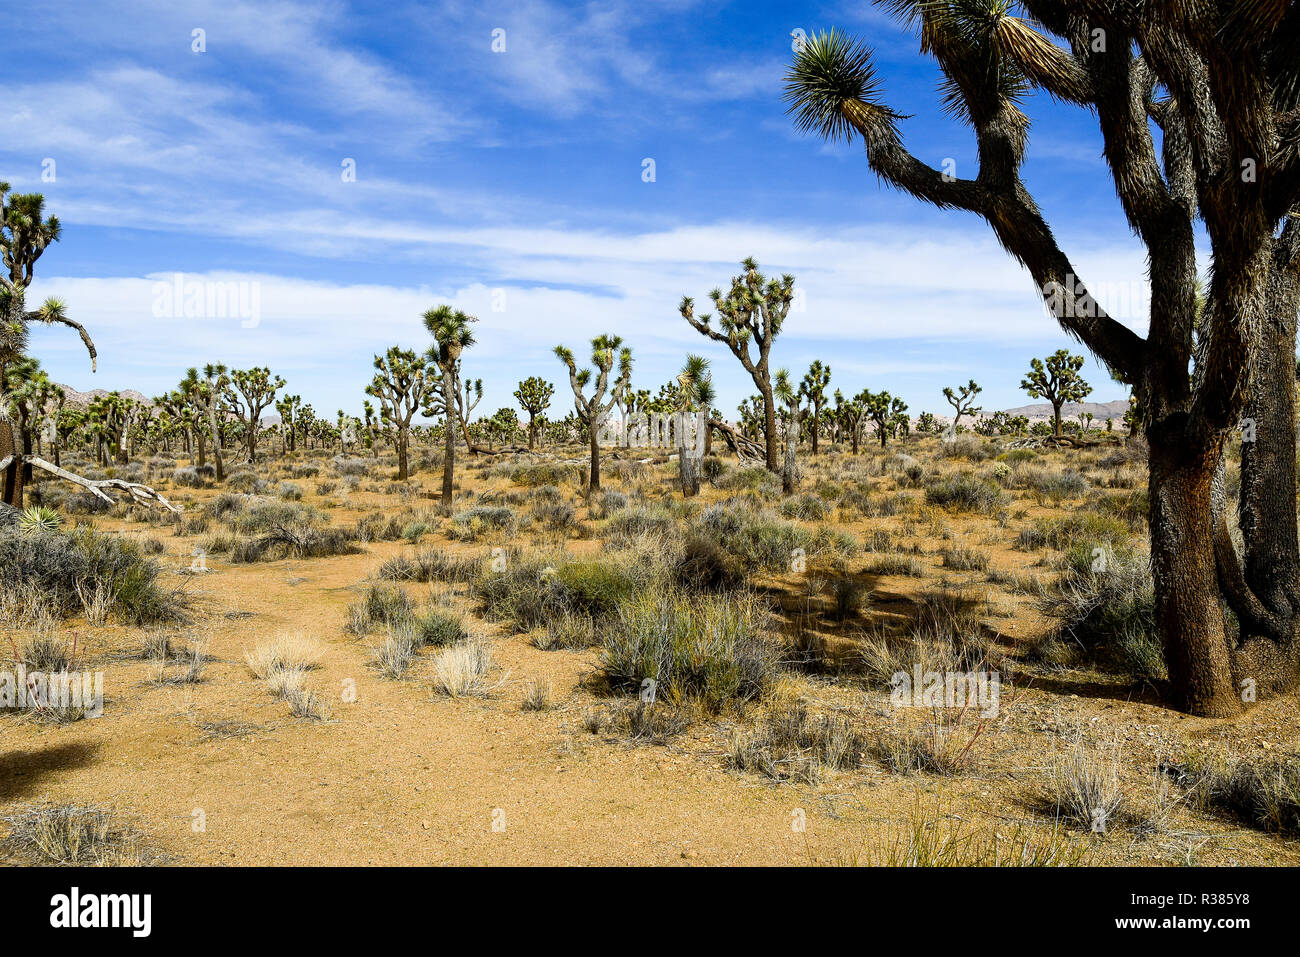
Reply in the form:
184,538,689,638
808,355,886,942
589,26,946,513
680,259,794,472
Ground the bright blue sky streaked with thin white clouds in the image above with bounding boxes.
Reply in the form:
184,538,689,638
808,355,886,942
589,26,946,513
0,0,1145,415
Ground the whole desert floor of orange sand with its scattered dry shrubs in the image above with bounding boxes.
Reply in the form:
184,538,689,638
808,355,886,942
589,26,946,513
0,436,1300,866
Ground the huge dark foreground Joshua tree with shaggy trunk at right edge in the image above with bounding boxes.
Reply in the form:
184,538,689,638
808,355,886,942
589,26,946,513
788,0,1300,715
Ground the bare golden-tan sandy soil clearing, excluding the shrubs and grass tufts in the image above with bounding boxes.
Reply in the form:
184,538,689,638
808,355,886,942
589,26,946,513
0,447,1300,865
